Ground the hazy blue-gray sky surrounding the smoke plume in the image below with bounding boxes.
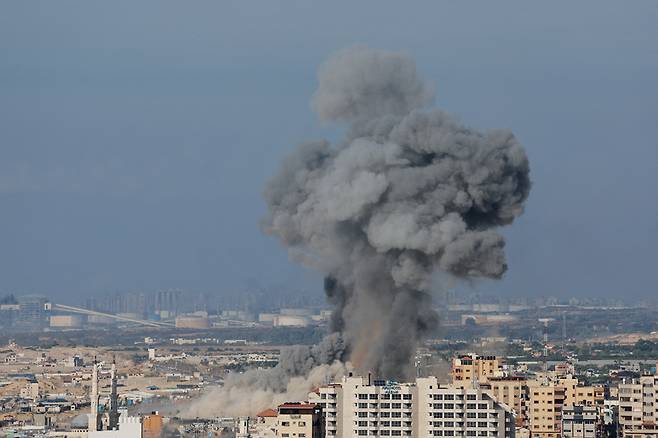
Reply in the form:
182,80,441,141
0,0,658,302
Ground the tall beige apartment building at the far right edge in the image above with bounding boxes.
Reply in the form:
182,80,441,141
618,375,658,438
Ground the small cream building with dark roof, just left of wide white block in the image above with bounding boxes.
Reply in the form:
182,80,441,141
276,402,324,438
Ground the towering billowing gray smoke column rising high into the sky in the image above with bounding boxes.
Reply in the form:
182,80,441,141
264,47,530,378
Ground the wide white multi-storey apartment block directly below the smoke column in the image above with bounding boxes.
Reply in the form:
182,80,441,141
310,376,514,438
